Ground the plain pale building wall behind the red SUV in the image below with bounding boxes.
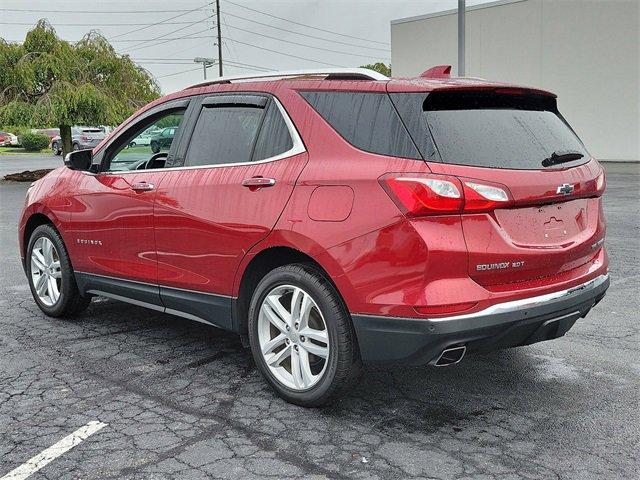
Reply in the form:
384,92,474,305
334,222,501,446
391,0,640,160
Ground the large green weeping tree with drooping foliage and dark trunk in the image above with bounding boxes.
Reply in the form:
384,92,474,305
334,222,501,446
0,20,160,155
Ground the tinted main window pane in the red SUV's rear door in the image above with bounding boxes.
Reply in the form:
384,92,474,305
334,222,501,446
186,106,264,166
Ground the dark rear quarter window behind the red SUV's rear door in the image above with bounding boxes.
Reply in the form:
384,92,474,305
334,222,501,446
301,92,421,159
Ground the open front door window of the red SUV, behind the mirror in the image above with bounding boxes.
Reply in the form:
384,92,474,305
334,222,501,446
107,108,185,172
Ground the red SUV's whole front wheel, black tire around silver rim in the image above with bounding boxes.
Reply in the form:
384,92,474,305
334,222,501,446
25,225,91,317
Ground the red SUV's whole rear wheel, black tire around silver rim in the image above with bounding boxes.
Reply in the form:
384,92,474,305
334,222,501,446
248,264,362,407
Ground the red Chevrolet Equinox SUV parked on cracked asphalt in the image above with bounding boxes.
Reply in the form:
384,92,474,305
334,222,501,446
19,69,609,406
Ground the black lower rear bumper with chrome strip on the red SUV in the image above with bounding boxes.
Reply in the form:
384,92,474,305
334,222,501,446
352,274,609,365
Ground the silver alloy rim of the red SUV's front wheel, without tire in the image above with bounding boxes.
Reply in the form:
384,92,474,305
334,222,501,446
31,237,62,307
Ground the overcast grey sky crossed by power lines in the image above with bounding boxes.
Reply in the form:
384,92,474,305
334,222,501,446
0,0,486,93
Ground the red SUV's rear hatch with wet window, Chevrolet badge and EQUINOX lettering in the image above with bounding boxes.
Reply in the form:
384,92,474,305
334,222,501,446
391,88,605,290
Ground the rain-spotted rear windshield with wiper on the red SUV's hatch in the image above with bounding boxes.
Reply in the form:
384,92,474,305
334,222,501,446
394,92,588,170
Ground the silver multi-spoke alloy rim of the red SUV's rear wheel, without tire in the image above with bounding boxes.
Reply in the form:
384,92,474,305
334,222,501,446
258,285,330,391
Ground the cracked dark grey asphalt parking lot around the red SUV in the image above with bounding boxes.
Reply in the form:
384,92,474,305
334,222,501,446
0,162,640,480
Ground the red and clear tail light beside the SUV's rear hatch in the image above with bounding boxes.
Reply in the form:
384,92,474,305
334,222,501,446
380,174,513,217
